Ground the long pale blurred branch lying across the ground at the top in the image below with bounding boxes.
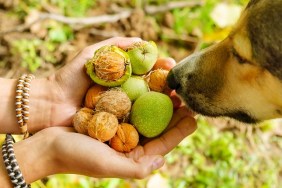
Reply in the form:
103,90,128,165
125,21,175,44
0,0,202,36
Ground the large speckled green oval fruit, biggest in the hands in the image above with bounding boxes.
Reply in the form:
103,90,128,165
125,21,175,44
130,91,173,138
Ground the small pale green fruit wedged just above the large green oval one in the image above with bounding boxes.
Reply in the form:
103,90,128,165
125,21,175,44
121,76,149,101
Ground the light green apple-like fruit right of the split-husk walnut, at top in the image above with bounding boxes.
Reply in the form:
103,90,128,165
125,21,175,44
126,41,158,75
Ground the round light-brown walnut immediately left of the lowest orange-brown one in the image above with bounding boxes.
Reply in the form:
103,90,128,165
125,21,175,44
87,112,118,142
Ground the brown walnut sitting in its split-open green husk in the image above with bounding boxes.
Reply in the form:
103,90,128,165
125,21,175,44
85,45,132,87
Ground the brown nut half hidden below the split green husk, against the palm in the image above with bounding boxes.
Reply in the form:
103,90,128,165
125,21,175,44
84,84,107,109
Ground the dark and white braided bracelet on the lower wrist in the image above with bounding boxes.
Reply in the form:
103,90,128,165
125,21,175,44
2,134,30,188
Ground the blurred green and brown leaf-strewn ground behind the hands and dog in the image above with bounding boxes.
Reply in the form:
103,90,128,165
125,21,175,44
0,0,282,188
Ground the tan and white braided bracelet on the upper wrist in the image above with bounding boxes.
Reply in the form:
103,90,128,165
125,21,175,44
15,74,35,139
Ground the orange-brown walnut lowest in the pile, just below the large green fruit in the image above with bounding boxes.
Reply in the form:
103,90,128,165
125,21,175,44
110,123,139,152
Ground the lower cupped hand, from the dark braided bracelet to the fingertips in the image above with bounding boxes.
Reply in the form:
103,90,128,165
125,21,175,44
2,107,196,183
